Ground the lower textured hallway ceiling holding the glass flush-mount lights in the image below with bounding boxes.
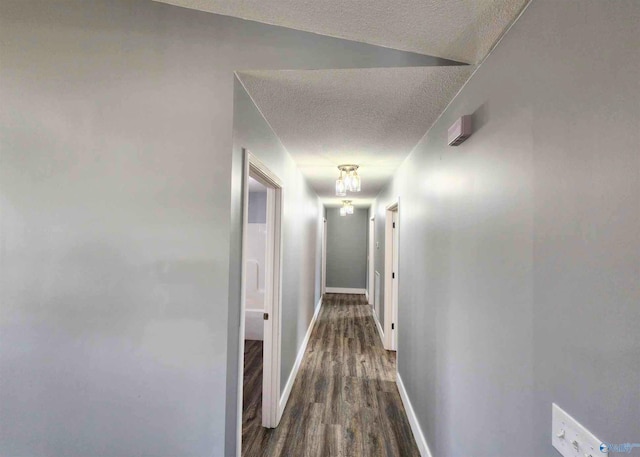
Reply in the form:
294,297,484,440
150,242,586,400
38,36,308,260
238,65,474,205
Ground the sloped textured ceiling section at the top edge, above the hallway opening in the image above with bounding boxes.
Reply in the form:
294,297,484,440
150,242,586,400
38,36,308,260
152,0,528,63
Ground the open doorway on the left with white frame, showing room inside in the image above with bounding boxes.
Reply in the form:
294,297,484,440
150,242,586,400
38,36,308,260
238,151,282,455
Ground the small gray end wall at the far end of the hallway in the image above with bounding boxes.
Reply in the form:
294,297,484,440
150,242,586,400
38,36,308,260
327,208,368,289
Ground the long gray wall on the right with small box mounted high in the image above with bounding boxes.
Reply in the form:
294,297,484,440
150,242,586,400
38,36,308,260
374,0,640,457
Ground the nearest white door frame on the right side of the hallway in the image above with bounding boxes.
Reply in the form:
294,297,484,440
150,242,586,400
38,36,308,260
384,197,400,351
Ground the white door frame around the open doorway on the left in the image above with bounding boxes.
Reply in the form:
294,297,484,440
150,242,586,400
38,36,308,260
236,149,283,456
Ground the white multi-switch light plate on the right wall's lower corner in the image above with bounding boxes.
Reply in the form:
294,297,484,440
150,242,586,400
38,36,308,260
551,403,609,457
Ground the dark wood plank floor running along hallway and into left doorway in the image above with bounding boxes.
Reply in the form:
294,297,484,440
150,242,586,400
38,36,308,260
242,294,420,457
